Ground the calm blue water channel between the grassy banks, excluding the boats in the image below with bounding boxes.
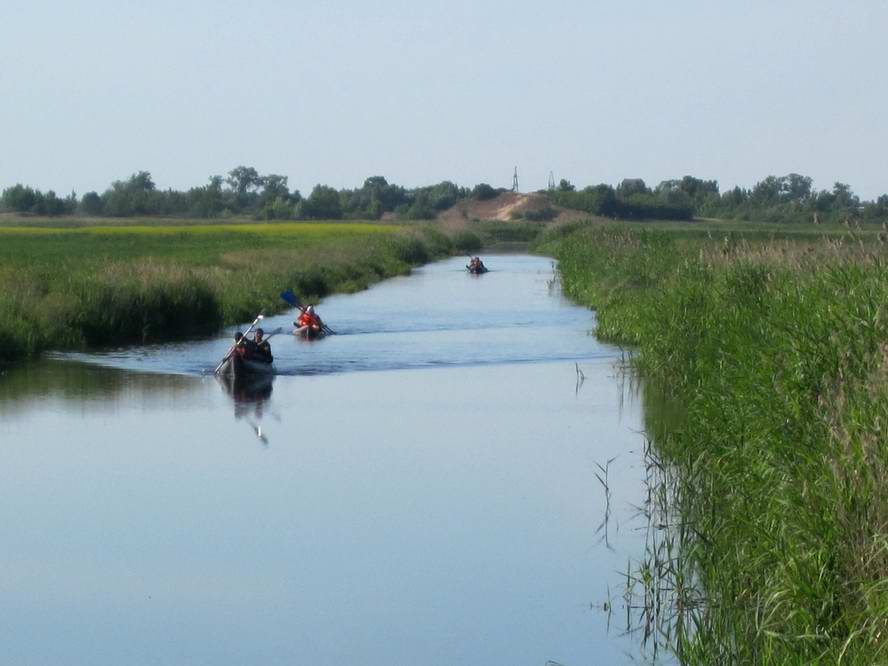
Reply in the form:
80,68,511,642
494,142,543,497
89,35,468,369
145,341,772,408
0,256,664,666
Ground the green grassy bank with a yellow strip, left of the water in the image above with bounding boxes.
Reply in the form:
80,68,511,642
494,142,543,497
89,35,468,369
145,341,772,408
0,220,452,362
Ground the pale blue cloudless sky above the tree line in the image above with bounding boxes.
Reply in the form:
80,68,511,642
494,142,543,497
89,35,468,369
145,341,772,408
0,0,888,199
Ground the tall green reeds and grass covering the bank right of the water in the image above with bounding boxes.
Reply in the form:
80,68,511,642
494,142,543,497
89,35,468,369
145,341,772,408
544,227,888,664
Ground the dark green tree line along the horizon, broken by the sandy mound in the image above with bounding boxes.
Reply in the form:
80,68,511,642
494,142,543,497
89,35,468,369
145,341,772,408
0,166,888,223
